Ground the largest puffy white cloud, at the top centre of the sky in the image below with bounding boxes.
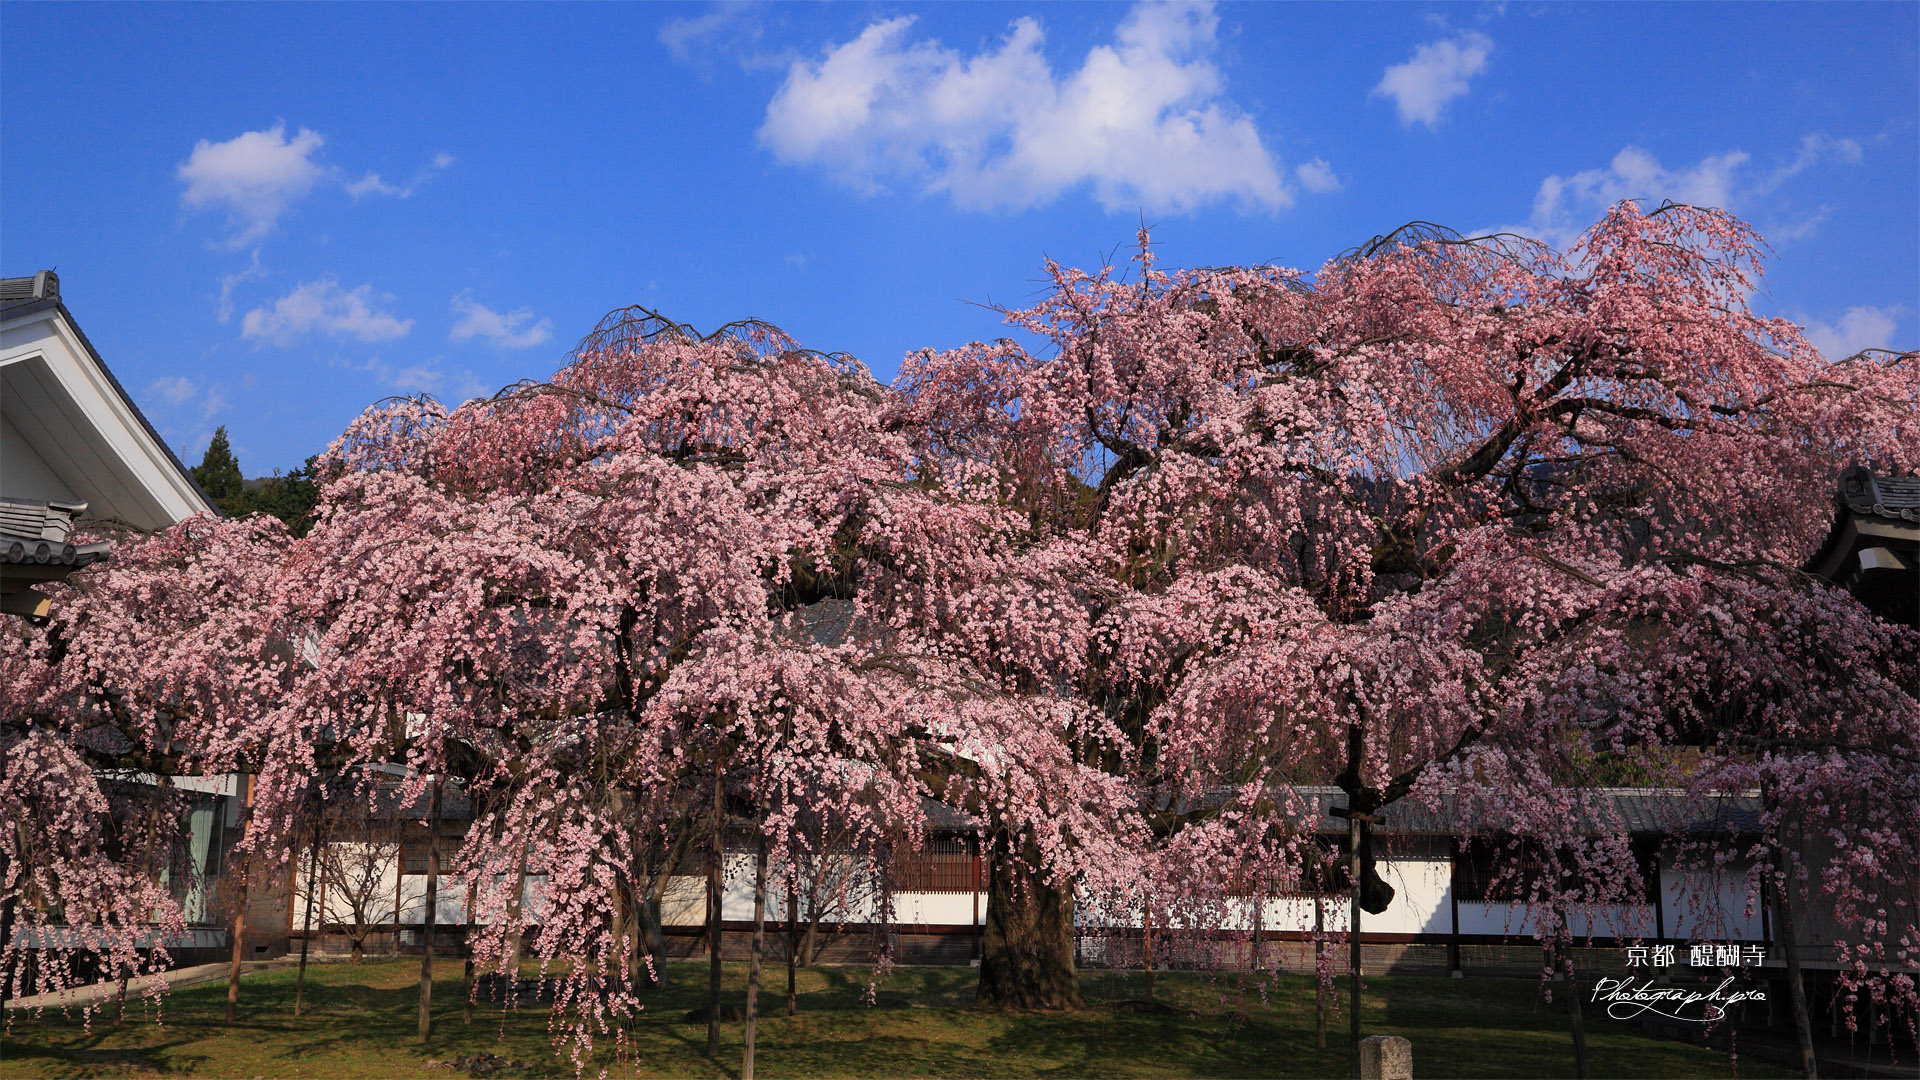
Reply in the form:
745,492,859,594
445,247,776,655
760,4,1292,211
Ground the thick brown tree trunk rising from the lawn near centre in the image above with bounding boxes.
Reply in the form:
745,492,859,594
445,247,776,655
977,836,1085,1009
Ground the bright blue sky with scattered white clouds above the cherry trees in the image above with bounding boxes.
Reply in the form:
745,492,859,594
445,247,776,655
0,4,1920,475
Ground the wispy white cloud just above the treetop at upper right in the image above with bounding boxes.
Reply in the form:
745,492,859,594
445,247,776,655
1490,135,1862,252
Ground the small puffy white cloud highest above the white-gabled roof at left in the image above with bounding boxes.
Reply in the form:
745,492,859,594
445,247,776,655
175,123,326,248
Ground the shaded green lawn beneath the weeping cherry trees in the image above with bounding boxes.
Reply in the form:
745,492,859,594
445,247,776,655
0,959,1789,1080
